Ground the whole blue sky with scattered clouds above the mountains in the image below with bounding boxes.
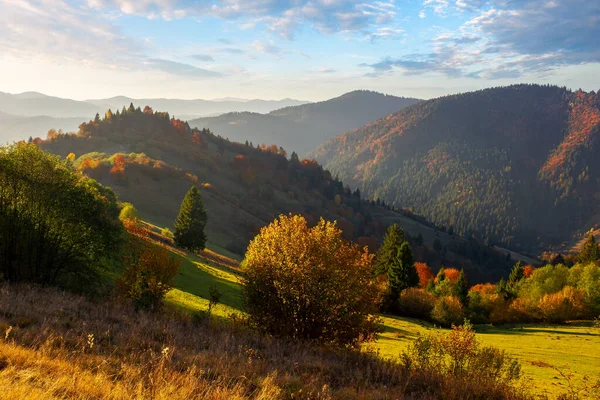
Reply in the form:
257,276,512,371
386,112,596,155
0,0,600,101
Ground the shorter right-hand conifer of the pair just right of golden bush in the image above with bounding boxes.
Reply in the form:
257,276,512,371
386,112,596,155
383,241,419,311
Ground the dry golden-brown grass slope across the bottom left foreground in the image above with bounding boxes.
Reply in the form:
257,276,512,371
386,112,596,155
0,285,522,400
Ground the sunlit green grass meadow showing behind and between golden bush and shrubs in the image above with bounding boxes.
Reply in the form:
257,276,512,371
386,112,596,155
167,245,600,398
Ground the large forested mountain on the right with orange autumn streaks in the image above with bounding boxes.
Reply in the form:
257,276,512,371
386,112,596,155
311,85,600,251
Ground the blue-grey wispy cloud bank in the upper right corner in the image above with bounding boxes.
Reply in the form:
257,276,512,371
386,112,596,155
362,0,600,79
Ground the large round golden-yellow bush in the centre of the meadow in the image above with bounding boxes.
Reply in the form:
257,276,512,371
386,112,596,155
243,215,379,345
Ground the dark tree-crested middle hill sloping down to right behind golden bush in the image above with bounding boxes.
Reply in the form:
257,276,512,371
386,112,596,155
36,108,518,282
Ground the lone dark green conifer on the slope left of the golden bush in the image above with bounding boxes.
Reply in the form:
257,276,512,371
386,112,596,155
174,186,207,252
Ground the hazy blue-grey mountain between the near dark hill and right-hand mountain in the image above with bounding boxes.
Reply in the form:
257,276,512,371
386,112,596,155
190,90,419,155
